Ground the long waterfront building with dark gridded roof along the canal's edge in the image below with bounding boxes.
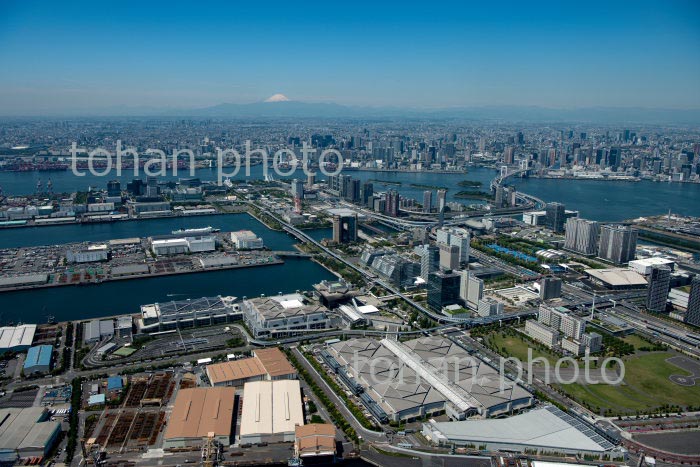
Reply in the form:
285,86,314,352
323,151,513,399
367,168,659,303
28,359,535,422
136,295,242,333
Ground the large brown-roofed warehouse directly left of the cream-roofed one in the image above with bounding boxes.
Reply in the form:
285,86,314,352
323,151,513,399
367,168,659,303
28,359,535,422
163,388,236,449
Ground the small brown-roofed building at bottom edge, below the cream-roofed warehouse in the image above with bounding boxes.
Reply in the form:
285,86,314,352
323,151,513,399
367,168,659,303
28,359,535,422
294,423,338,466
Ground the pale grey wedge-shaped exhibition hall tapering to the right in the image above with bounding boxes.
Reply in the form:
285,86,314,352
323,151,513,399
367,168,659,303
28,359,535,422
423,406,615,456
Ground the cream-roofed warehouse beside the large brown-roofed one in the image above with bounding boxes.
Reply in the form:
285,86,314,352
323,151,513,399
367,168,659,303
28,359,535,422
239,380,304,444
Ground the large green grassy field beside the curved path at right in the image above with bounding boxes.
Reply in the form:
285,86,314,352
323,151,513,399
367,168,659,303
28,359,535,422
558,352,700,414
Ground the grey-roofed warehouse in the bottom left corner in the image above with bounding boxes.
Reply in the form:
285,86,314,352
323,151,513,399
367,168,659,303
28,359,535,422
0,407,61,458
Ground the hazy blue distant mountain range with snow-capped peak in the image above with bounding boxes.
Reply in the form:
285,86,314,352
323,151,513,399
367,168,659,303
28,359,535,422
5,100,700,124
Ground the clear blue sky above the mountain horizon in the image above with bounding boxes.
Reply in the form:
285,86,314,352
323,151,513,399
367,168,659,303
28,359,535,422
0,0,700,115
